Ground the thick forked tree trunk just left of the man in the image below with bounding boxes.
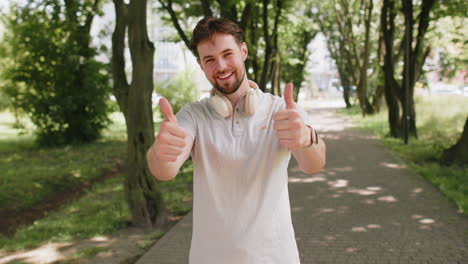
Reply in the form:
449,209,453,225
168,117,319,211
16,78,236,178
112,0,164,226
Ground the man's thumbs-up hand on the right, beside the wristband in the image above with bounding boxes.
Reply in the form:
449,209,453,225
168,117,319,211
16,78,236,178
273,83,312,150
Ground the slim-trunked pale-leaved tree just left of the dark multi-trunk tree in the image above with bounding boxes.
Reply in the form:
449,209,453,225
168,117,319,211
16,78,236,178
315,0,383,112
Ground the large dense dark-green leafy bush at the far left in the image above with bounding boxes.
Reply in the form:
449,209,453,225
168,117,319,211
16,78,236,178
1,1,110,145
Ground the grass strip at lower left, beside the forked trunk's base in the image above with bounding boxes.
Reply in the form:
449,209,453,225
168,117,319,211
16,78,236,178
0,176,130,250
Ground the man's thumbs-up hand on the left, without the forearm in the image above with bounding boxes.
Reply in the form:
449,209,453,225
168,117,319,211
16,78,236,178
153,98,187,162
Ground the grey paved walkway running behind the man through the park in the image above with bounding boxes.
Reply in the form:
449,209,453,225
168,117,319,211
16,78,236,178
137,105,468,264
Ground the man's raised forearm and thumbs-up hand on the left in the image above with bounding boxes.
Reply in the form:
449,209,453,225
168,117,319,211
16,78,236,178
146,98,193,181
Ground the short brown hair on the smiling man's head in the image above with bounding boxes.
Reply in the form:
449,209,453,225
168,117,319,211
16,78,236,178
189,17,244,58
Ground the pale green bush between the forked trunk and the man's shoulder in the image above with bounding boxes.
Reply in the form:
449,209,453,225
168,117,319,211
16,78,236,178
155,71,200,113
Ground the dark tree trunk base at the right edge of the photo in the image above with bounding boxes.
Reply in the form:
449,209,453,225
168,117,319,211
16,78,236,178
442,118,468,166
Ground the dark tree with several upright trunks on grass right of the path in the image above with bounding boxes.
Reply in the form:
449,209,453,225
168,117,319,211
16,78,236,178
381,0,436,140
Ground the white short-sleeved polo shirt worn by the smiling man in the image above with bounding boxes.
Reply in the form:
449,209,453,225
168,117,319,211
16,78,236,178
176,89,309,264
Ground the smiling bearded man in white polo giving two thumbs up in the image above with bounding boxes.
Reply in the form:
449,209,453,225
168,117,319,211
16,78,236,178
147,17,325,264
